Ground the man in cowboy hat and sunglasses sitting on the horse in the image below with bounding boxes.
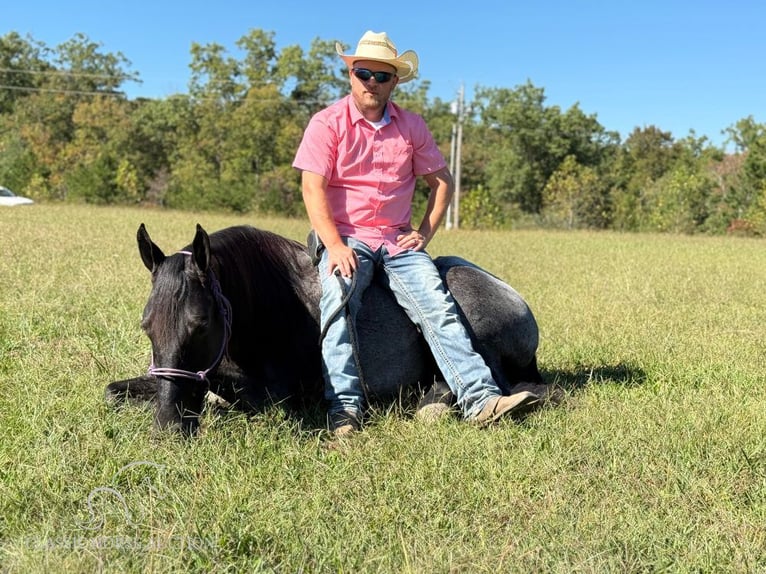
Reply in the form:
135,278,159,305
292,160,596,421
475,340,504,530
293,31,540,436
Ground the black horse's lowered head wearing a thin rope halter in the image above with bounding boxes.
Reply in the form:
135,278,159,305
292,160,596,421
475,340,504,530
137,224,230,434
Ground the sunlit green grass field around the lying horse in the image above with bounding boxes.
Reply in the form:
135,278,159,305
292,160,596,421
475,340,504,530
0,205,766,573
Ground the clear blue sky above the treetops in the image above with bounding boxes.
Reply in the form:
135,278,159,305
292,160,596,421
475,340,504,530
6,0,766,144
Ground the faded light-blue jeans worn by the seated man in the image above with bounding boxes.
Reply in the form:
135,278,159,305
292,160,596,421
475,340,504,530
319,238,502,419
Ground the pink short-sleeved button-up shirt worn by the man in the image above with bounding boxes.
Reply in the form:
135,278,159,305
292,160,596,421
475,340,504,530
293,95,446,255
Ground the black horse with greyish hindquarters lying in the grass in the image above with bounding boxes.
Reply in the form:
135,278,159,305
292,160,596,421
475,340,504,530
106,224,543,434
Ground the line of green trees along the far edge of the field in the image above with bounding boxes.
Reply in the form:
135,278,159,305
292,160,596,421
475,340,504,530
0,29,766,235
